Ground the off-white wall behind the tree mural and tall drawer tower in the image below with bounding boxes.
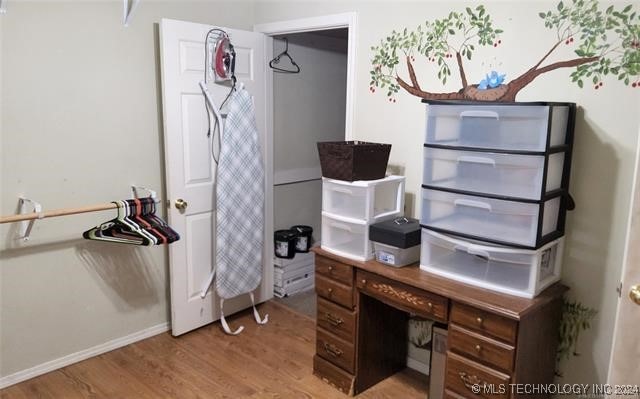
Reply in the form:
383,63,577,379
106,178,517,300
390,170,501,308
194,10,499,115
256,1,640,383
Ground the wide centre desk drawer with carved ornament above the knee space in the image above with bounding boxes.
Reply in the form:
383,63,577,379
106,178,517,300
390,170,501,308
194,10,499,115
356,270,449,323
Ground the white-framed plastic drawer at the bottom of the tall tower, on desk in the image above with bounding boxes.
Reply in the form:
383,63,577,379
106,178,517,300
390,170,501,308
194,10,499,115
420,229,564,298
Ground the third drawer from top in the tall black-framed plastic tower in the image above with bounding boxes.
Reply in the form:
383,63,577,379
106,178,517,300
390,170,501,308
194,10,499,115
420,188,565,248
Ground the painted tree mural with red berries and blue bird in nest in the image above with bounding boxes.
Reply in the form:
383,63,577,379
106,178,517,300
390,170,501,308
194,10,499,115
370,0,640,101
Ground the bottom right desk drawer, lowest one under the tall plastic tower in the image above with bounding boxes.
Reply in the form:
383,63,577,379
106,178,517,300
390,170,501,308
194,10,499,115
445,352,510,399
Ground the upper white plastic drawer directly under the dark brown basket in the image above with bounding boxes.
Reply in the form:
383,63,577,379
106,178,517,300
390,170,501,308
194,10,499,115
322,176,404,222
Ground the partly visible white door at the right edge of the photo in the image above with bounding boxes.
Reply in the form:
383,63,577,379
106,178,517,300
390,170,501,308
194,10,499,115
608,134,640,390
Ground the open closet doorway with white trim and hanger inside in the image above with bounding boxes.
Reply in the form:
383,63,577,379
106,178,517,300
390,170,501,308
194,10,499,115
255,14,355,317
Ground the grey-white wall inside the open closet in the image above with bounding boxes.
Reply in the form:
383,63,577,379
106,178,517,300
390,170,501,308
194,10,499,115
273,33,347,241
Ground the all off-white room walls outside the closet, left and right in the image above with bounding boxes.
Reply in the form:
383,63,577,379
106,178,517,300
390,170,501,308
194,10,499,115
0,1,640,390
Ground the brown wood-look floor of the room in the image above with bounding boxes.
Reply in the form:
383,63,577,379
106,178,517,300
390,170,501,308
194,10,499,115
0,301,428,399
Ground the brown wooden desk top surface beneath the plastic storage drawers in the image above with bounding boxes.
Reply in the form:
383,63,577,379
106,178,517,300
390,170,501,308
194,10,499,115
313,248,568,320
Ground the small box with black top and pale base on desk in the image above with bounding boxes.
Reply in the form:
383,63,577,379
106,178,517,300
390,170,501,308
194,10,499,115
369,217,421,266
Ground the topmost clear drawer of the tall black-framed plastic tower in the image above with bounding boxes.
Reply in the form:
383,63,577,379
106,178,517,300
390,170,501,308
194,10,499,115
425,101,575,152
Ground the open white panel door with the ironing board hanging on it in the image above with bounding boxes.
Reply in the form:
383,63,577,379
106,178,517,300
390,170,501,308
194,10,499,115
160,19,273,335
